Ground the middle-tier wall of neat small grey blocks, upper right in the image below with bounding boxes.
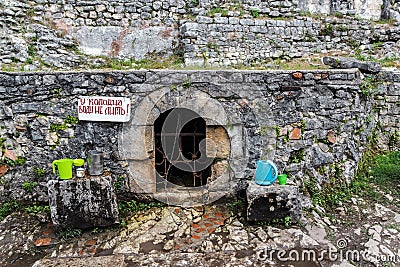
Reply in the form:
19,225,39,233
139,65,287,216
181,16,400,67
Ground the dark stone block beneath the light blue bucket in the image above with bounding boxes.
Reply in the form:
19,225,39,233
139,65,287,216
246,181,302,222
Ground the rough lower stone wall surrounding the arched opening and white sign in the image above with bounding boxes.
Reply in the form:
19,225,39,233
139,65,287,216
0,69,400,205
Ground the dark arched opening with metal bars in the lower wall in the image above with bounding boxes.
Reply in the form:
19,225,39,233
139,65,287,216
154,108,211,187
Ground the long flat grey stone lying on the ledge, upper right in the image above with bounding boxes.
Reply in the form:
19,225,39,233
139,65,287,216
322,57,382,73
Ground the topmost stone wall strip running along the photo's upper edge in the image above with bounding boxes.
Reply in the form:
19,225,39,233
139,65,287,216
4,0,386,26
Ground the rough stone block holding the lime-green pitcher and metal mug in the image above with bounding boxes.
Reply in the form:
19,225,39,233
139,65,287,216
47,176,119,228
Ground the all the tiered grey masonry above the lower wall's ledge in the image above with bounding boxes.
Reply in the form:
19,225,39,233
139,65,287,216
0,0,400,71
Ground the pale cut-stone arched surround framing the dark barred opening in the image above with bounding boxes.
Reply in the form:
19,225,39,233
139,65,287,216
119,82,276,206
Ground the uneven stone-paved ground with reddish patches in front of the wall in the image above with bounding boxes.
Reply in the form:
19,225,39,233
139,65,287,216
0,198,400,267
